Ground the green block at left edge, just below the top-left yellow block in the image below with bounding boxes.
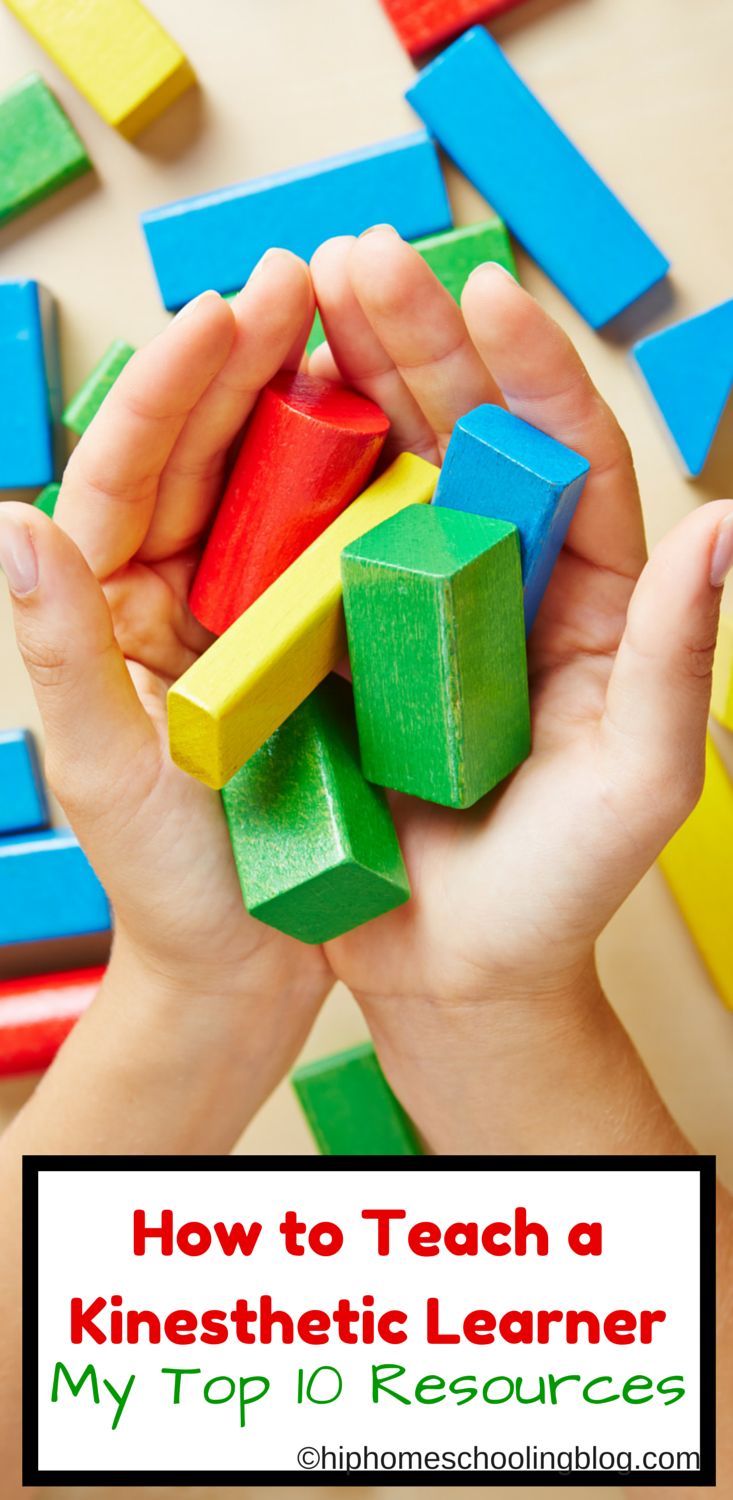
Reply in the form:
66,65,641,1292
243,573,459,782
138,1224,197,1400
0,74,91,224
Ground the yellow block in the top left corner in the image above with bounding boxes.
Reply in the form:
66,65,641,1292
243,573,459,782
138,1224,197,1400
6,0,193,138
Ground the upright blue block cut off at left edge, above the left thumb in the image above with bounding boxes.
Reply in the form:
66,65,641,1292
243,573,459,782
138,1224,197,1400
0,281,61,489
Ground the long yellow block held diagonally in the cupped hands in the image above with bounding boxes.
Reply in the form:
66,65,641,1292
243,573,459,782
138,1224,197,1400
168,453,438,788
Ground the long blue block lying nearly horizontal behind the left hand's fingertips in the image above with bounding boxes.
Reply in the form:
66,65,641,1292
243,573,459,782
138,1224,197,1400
141,131,453,309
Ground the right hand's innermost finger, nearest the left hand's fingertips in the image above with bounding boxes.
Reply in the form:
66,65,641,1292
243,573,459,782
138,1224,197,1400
309,234,438,462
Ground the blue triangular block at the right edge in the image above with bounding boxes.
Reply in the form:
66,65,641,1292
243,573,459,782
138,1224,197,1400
634,297,733,474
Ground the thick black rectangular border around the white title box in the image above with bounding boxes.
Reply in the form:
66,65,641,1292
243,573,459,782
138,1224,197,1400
22,1157,715,1488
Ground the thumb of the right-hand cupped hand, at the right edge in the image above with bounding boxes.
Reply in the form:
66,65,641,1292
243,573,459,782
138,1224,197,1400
601,500,733,837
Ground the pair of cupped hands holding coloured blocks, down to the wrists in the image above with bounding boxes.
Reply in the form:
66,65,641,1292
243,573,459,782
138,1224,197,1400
0,227,733,1146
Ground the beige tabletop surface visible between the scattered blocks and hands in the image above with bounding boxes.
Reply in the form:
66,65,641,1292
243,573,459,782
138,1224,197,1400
0,0,733,1496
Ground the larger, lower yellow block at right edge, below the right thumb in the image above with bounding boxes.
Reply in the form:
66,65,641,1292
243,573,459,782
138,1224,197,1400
660,737,733,1010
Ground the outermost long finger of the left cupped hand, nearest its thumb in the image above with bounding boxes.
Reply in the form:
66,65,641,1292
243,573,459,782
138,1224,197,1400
54,293,235,578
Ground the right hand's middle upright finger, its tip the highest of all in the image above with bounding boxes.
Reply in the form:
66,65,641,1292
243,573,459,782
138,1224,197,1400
346,227,502,453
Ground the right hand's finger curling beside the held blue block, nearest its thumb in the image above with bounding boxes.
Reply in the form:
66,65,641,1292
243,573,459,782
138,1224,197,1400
462,264,646,578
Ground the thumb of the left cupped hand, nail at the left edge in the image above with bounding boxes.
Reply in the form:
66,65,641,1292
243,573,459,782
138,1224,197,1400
0,503,157,855
